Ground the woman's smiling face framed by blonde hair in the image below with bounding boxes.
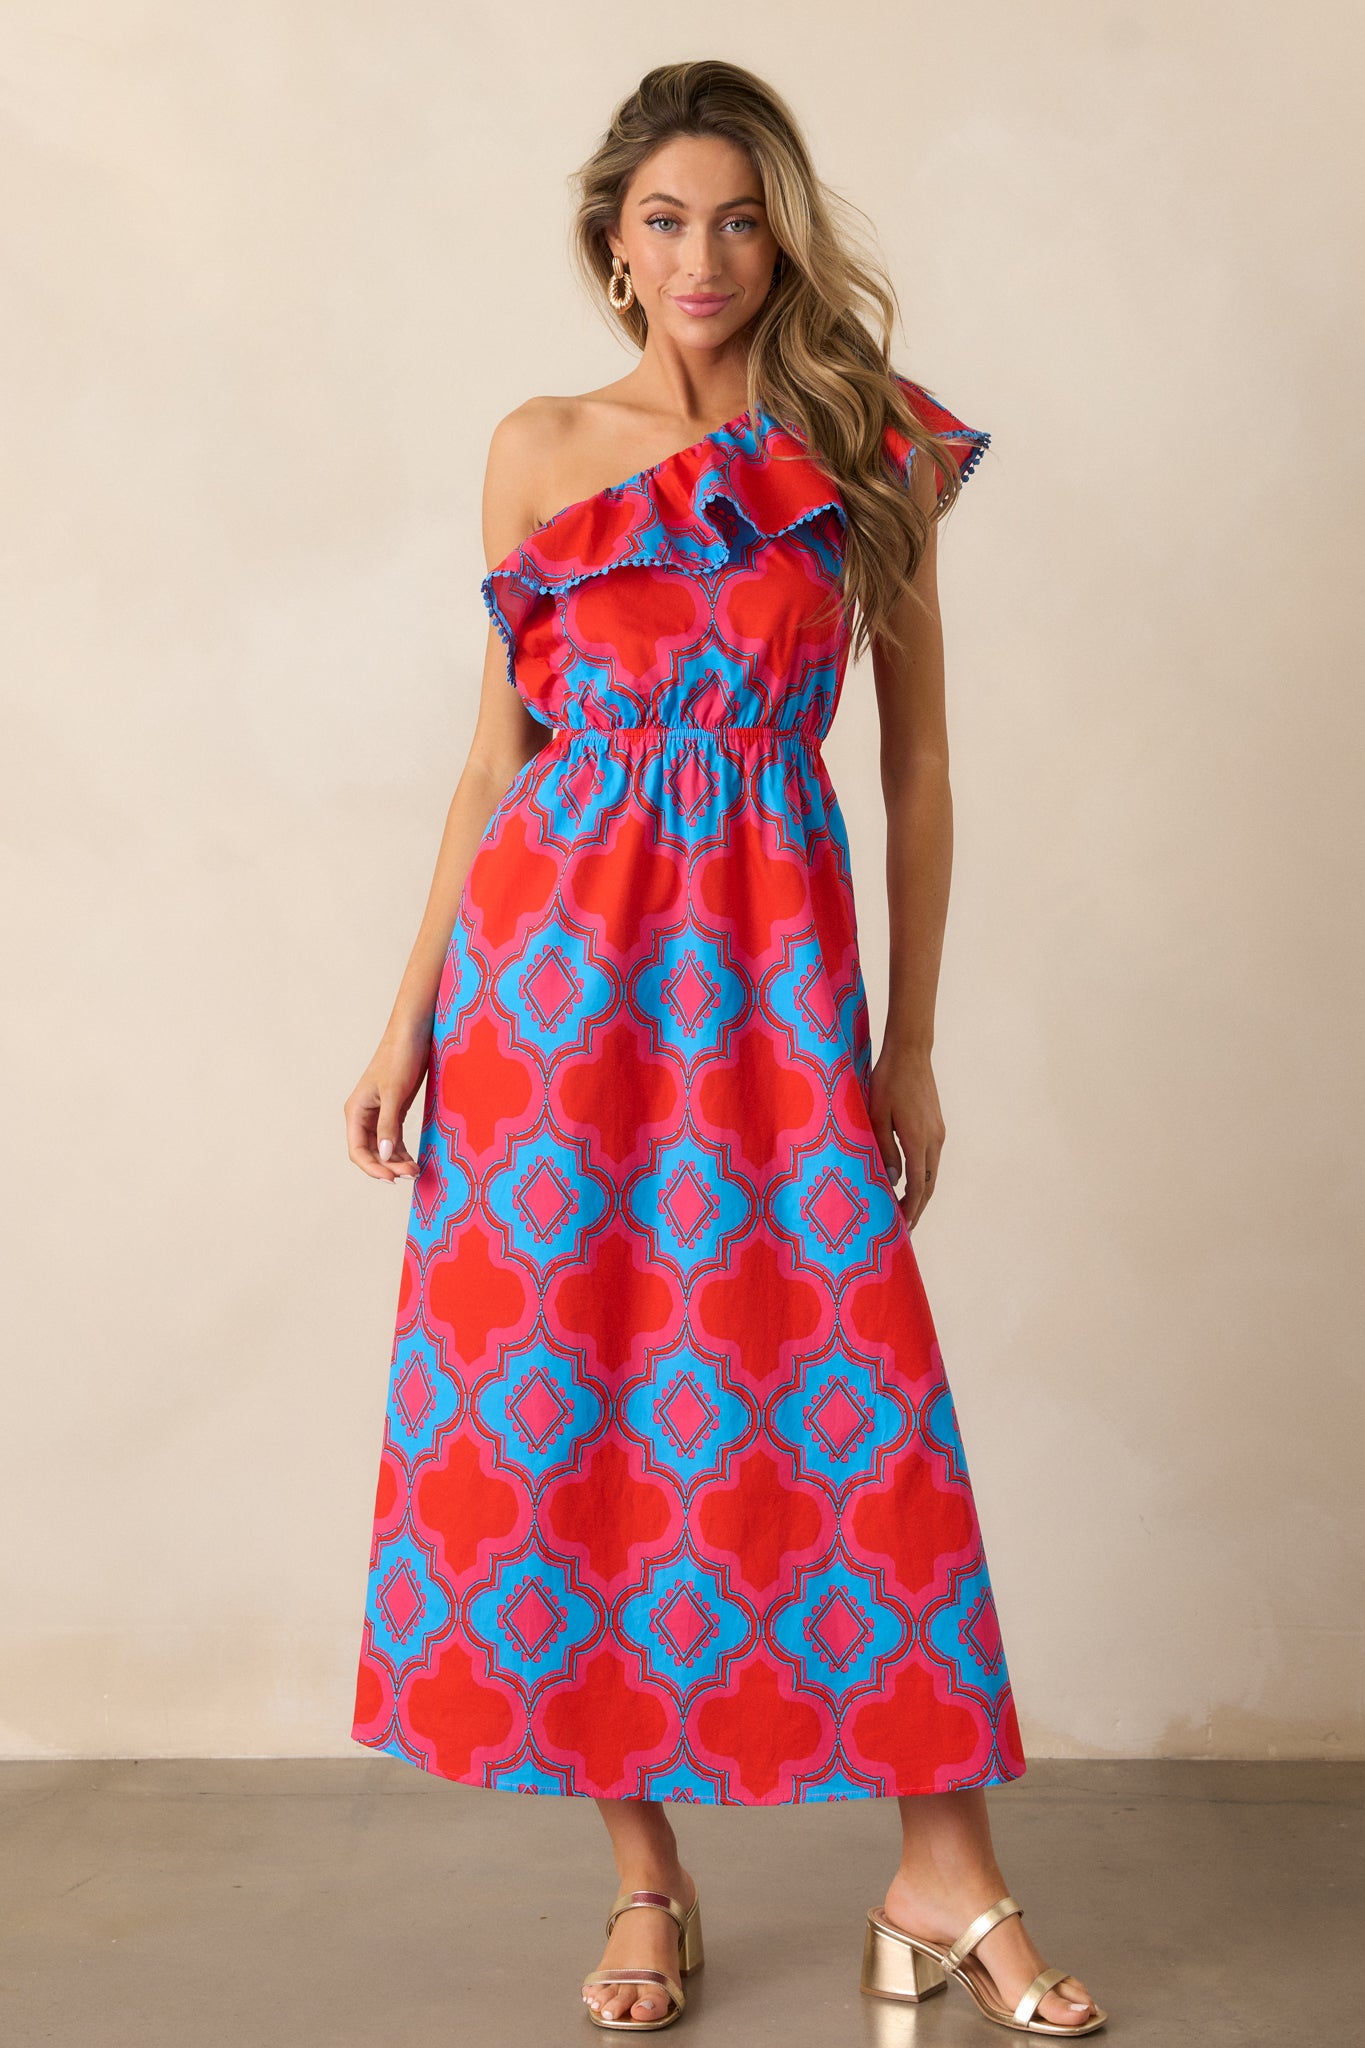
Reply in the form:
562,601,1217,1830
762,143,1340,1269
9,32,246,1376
608,135,778,348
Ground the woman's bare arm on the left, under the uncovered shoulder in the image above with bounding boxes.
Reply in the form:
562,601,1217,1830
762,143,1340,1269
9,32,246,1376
346,408,548,1182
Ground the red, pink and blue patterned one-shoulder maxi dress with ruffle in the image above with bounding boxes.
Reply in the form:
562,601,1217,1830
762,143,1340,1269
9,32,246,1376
352,379,1023,1806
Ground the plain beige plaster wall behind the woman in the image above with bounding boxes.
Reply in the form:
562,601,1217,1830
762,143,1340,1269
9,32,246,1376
0,0,1365,1757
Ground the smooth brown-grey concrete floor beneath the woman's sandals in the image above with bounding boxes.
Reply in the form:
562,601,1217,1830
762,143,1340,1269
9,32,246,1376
0,1757,1365,2048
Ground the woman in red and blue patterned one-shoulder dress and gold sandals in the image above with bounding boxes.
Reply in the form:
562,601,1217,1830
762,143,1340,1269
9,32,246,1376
346,63,1105,2034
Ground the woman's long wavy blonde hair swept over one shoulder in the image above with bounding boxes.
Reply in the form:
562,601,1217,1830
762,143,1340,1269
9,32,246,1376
571,59,978,655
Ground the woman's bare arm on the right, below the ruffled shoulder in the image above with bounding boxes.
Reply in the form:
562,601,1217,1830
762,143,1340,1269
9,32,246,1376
870,459,954,1229
